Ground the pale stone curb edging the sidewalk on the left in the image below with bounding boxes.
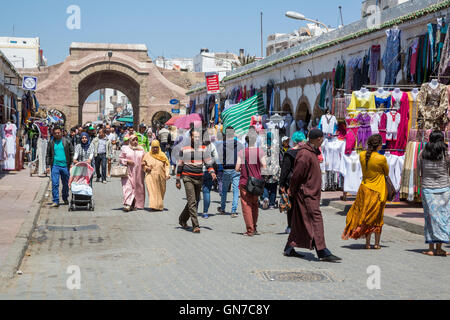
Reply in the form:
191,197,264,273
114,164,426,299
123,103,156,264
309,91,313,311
0,178,50,279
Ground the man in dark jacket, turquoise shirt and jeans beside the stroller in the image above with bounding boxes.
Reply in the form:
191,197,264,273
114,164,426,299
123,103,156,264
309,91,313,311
46,127,74,208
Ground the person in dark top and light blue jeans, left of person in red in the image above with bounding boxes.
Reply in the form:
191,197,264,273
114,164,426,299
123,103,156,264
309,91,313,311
217,126,244,218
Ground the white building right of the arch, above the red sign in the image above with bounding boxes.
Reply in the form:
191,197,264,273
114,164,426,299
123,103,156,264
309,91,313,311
194,49,239,80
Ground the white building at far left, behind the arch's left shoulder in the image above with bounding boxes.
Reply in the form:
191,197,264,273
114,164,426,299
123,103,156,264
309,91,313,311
0,37,47,68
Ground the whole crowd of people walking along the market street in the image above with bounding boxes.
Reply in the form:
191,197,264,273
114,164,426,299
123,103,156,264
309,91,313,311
47,120,450,262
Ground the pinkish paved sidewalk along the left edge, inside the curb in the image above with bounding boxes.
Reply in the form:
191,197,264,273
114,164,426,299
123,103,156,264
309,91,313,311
0,169,49,273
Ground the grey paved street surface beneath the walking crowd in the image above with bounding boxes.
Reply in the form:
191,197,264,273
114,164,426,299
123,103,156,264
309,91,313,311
0,174,450,299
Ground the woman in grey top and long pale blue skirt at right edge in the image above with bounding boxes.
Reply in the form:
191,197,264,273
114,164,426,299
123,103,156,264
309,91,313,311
417,130,450,256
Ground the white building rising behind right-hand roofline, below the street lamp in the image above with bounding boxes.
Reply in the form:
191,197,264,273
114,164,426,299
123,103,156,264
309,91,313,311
266,23,333,56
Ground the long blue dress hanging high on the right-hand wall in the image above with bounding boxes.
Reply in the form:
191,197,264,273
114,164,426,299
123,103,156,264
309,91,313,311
381,29,401,85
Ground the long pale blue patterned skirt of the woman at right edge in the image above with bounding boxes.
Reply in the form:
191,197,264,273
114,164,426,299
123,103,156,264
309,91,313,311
422,187,450,243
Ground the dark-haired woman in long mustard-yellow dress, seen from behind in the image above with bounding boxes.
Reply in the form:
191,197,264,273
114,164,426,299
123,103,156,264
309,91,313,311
342,134,389,249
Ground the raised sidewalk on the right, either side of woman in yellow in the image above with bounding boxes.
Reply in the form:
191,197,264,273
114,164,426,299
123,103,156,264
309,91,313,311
322,191,424,235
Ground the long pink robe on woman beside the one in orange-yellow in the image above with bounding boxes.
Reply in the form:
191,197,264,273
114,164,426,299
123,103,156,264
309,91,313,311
119,146,145,209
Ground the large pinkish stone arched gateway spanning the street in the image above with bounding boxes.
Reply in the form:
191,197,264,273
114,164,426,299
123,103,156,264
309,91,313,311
19,43,188,127
